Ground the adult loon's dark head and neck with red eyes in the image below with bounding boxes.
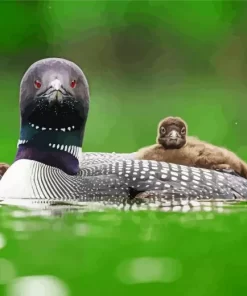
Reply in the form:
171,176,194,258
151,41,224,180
16,58,89,174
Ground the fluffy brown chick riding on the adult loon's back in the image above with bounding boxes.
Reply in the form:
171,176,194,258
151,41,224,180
137,117,247,178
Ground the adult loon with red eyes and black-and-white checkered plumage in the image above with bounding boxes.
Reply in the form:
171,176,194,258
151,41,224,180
0,58,247,207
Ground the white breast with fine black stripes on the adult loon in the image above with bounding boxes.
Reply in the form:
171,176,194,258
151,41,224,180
0,159,78,201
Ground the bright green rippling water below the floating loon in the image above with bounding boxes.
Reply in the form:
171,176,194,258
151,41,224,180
0,204,247,296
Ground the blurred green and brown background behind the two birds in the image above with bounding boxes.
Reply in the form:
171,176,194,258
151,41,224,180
0,0,247,162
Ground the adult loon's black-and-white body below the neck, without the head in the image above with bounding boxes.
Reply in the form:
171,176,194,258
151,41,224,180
0,153,247,209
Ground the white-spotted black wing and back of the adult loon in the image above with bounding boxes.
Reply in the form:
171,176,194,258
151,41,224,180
77,159,247,200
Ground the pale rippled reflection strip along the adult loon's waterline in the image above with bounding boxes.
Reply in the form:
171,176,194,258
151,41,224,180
0,200,247,219
